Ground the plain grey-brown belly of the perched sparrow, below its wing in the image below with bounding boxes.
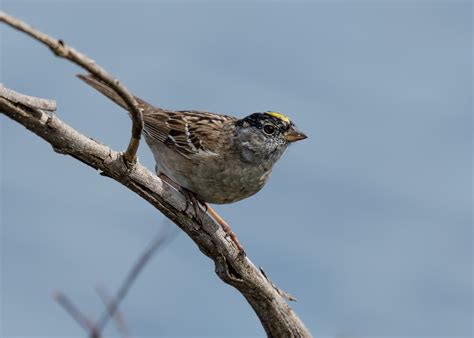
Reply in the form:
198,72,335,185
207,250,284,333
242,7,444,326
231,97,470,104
151,144,271,204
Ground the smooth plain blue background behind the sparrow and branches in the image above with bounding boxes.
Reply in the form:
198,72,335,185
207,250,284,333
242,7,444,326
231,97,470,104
0,0,473,337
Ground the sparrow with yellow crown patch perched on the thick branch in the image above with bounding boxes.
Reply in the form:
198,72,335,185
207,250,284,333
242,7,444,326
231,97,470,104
77,74,307,252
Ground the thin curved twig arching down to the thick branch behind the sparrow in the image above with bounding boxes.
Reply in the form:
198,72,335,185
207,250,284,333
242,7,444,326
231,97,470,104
0,11,143,163
